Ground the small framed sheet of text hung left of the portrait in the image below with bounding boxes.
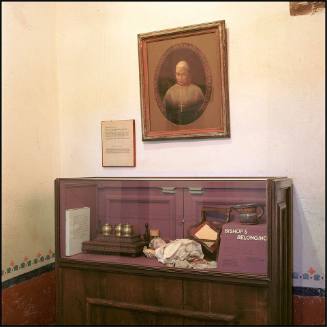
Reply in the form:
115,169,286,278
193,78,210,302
101,119,135,167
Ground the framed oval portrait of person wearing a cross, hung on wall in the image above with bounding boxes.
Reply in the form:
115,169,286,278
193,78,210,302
138,21,230,141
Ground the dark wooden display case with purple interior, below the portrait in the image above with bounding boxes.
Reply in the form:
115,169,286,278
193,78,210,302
55,177,292,325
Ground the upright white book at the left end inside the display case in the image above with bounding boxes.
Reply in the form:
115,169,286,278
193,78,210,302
66,207,90,256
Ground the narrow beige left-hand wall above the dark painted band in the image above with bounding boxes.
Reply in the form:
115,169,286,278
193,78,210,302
2,2,60,280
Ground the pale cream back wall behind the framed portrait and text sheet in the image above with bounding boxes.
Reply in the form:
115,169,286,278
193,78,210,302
1,2,325,287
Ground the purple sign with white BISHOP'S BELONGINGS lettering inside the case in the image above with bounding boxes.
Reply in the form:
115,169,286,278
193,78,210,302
217,222,268,275
